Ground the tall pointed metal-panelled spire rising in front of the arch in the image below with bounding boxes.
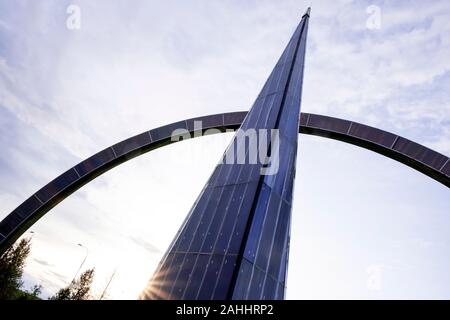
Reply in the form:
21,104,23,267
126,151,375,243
140,8,310,299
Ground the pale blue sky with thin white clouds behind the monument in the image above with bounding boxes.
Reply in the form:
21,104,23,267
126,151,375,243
0,0,450,299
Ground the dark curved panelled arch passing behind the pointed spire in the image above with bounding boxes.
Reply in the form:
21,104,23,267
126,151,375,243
0,112,450,254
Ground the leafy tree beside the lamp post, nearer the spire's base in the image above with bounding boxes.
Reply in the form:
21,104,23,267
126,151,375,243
50,269,94,300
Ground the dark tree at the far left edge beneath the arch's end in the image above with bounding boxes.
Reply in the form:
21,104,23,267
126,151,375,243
0,238,31,300
